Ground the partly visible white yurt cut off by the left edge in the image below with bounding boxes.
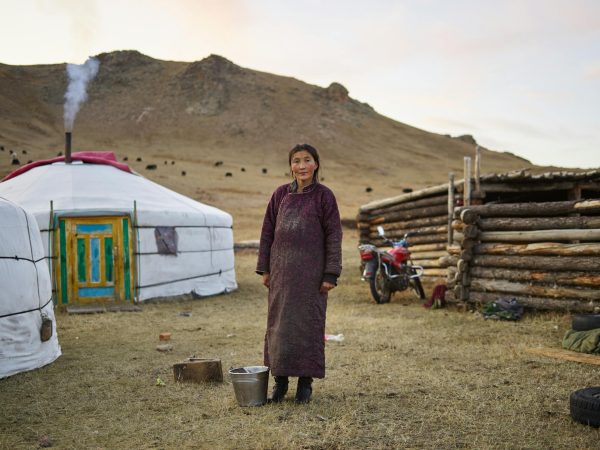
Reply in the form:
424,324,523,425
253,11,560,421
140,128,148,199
0,197,61,378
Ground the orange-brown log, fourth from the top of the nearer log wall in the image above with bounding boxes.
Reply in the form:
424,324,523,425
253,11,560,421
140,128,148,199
473,242,600,256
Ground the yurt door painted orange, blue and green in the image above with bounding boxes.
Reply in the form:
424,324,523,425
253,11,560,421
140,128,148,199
59,217,132,303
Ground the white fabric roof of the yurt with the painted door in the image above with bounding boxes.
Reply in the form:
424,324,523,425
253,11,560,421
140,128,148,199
0,155,232,227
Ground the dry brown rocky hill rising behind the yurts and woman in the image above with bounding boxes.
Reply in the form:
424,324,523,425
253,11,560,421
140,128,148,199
0,51,531,237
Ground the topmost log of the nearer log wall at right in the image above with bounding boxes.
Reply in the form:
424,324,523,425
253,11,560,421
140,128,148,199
459,200,600,217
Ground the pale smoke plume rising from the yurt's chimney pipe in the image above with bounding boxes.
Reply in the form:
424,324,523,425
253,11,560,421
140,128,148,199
64,58,100,133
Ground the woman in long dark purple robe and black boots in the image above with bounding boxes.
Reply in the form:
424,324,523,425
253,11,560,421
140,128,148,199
256,144,342,403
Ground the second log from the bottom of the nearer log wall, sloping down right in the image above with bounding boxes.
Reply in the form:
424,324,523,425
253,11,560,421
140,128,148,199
471,278,600,301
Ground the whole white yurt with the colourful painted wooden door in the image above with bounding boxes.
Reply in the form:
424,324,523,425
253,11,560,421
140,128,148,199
0,152,237,305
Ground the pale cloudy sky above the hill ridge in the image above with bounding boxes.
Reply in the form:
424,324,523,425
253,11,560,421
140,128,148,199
0,0,600,168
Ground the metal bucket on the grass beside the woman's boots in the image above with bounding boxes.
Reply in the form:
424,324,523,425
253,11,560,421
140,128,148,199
229,366,269,406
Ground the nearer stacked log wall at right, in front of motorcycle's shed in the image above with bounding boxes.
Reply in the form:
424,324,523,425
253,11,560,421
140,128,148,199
447,199,600,312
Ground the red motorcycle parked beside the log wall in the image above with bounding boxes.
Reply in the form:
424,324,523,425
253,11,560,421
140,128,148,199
358,226,425,303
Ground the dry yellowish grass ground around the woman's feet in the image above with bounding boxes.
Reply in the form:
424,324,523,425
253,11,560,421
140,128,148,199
0,232,600,449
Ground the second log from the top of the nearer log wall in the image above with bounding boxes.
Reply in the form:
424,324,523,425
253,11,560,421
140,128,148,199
478,216,600,231
